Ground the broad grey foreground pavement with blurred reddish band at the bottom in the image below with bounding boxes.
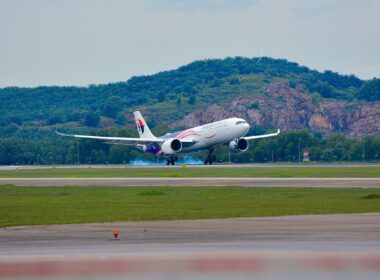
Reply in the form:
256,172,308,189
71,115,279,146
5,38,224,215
0,214,380,279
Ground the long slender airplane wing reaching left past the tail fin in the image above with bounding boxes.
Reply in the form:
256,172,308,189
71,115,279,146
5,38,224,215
55,131,165,145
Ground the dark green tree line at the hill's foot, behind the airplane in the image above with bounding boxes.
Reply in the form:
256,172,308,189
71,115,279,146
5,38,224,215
0,126,380,165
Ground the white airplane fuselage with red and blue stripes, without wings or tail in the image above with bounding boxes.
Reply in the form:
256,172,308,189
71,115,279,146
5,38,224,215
163,118,249,153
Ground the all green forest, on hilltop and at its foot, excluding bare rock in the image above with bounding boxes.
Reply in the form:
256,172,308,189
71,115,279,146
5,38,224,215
0,57,380,164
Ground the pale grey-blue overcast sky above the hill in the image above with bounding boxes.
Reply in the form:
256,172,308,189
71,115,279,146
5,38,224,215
0,0,380,87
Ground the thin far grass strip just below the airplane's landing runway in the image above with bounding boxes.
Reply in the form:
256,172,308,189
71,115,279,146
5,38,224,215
0,166,380,178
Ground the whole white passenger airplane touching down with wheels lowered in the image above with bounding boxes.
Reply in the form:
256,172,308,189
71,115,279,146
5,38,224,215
56,111,280,165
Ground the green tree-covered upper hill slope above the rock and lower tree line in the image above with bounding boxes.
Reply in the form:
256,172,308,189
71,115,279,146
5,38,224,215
0,57,368,128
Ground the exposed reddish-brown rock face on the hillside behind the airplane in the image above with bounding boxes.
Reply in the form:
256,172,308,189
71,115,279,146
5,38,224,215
173,82,380,137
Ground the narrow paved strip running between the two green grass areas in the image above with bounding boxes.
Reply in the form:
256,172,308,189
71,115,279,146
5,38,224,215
0,177,380,188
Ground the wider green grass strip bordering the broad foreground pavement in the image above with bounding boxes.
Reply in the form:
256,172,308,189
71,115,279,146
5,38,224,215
0,186,380,227
